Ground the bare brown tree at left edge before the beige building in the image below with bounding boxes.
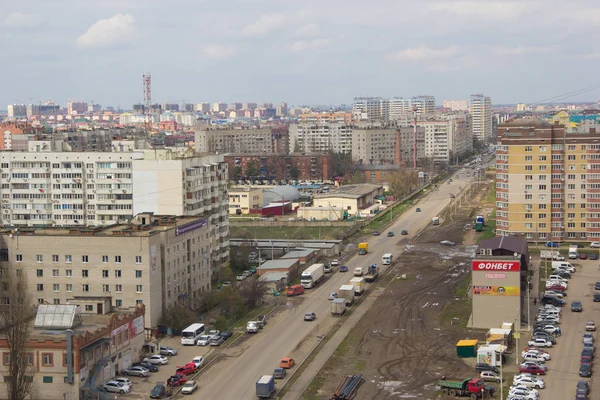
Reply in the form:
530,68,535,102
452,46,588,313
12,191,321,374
0,271,36,400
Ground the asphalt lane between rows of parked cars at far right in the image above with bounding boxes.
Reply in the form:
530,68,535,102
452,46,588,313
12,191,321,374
540,260,600,400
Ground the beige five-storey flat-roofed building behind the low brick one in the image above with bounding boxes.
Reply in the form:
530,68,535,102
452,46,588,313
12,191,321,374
0,214,213,327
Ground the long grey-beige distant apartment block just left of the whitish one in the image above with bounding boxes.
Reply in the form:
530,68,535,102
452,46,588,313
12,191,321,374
194,126,282,154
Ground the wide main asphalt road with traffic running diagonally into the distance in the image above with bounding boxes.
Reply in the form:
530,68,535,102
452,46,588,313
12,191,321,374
195,173,473,399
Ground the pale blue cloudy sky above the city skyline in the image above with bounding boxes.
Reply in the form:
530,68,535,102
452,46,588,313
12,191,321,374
0,0,600,108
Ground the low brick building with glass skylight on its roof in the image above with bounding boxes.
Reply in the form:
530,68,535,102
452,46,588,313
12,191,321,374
0,300,146,400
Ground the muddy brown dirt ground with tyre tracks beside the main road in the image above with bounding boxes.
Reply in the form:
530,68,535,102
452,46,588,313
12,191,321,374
312,192,484,399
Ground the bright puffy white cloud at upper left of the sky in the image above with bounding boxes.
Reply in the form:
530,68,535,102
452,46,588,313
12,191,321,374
76,13,135,48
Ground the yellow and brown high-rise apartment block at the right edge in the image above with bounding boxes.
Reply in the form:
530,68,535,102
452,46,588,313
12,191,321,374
496,119,600,241
